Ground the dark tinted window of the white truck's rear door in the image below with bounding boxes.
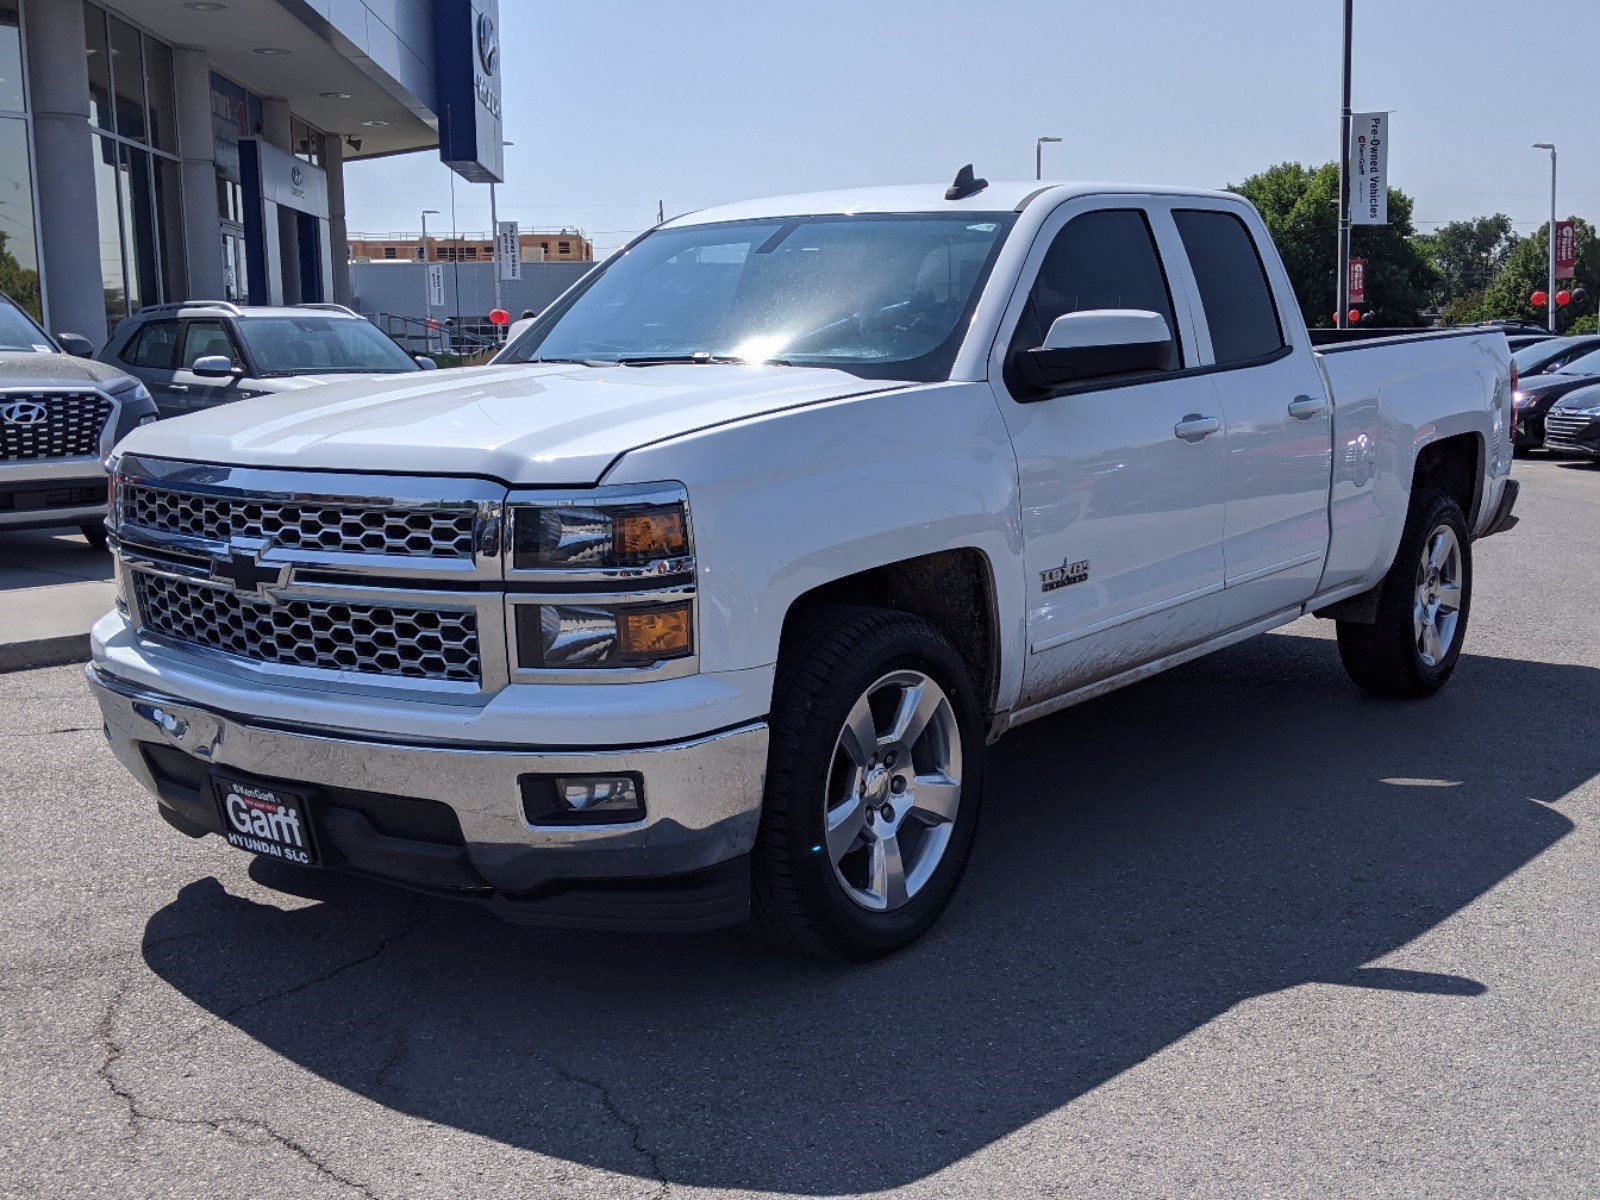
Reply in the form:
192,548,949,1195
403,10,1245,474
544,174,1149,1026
1173,210,1285,366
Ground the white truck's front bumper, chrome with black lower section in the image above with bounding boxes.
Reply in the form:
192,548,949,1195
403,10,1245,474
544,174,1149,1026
88,664,766,930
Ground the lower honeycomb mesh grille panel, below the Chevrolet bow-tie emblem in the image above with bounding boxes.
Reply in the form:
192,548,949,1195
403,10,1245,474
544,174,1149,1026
134,571,483,683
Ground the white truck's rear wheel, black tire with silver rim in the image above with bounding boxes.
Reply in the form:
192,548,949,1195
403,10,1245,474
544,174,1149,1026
1338,491,1472,698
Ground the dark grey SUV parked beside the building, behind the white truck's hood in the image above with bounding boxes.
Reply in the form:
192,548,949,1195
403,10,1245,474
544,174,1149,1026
99,301,434,416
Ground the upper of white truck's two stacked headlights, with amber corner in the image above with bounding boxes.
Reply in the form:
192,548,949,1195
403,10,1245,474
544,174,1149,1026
512,501,690,574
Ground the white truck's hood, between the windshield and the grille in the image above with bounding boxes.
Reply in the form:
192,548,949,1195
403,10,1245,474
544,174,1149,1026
117,363,906,485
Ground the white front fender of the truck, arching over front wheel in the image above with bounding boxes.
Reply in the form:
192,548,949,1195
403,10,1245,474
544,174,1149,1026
603,382,1024,709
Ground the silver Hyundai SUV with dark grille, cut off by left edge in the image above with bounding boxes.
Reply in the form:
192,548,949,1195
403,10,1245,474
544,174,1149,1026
0,293,155,552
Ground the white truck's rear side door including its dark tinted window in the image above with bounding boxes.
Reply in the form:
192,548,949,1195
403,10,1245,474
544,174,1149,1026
1173,200,1333,632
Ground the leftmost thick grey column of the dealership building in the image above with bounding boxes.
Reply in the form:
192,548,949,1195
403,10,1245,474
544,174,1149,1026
24,0,106,347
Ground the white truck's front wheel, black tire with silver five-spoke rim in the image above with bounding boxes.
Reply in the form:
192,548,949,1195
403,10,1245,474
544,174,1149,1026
754,608,984,960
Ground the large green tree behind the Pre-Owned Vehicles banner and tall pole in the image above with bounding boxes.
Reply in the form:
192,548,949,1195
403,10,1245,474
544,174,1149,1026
1229,163,1435,326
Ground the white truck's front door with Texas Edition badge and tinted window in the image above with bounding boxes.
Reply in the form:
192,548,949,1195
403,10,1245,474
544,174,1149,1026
990,198,1226,706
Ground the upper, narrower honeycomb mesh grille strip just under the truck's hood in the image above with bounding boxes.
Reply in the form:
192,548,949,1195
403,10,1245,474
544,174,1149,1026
122,483,477,562
